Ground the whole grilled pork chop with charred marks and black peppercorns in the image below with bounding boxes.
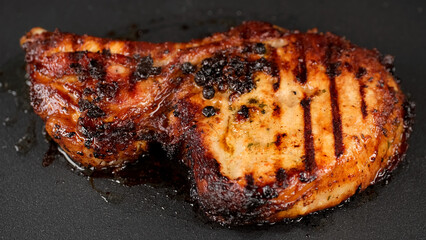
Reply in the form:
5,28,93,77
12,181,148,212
21,22,409,224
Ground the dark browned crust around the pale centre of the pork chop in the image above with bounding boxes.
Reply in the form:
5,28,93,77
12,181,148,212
21,22,412,224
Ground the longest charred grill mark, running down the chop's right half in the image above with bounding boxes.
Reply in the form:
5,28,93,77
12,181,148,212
325,46,344,158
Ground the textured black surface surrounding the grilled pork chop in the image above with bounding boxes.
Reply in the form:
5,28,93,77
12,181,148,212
0,0,426,239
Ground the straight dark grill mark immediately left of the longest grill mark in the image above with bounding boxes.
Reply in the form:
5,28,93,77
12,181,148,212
300,97,316,173
